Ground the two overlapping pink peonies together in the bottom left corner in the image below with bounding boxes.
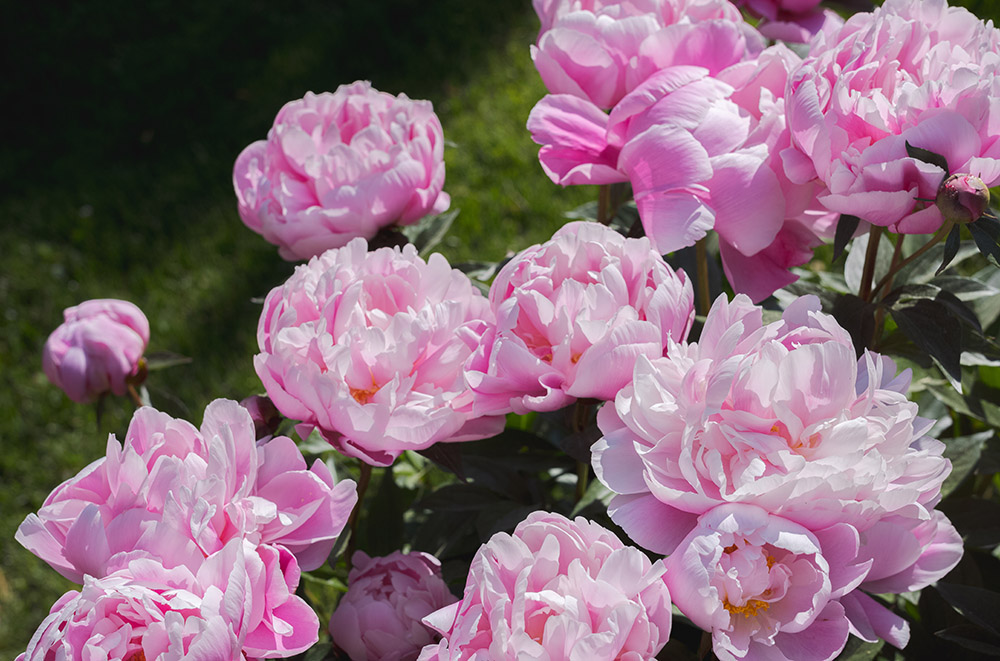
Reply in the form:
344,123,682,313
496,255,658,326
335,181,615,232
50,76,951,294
16,400,357,661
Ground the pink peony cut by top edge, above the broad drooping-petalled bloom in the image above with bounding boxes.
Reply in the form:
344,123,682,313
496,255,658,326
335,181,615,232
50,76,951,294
531,0,764,109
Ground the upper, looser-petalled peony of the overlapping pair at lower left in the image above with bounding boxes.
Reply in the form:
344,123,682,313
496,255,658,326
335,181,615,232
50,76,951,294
15,400,357,582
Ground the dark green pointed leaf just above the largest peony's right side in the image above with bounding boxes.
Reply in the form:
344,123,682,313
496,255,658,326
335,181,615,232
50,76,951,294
892,298,962,387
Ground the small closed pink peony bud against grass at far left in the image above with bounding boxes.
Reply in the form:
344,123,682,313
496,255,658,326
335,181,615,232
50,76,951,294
42,298,149,404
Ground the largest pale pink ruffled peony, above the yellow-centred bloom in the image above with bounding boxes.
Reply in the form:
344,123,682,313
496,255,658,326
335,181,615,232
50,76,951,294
593,296,951,553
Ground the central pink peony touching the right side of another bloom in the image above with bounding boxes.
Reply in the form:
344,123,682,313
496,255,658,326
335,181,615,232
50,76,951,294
466,222,694,413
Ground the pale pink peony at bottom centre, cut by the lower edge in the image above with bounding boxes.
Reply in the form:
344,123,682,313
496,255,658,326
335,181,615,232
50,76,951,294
419,512,671,661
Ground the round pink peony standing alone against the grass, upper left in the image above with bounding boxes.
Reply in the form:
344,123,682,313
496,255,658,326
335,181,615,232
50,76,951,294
233,82,450,260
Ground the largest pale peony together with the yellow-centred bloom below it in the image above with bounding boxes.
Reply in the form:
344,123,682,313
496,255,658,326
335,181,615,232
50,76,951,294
593,297,962,659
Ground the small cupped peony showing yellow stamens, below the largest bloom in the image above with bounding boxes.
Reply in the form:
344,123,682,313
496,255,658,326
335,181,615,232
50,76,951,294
664,504,868,661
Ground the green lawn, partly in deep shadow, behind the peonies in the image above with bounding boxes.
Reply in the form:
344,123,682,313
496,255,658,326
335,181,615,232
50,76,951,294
0,0,1000,658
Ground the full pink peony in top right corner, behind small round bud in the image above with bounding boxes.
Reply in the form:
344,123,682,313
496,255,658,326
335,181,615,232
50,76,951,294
782,0,1000,234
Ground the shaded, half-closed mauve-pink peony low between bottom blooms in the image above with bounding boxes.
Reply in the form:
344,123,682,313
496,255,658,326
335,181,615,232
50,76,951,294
330,551,457,661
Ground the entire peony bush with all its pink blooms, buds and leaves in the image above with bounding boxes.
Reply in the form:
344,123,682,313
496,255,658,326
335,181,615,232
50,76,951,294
15,0,1000,661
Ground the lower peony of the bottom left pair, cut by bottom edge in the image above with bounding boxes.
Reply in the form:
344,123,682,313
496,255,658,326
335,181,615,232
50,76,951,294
18,539,319,661
